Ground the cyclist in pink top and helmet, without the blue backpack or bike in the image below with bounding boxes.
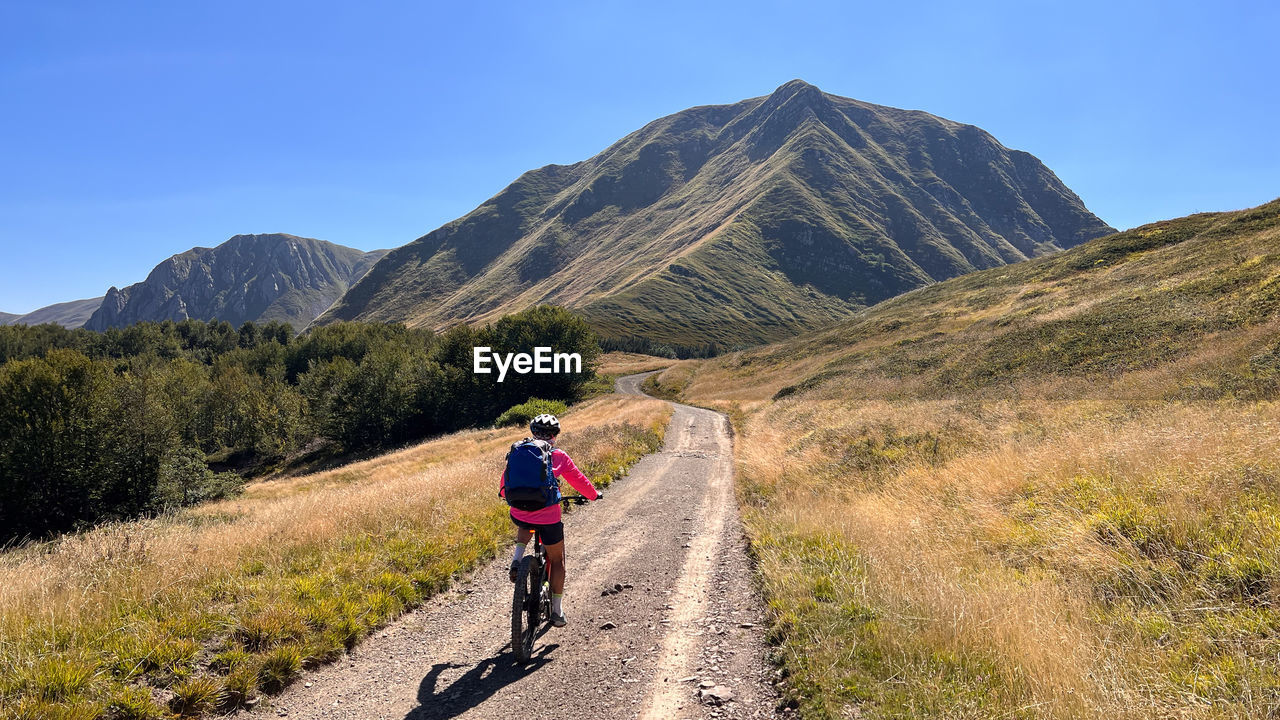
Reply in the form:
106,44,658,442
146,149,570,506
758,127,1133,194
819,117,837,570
498,415,600,628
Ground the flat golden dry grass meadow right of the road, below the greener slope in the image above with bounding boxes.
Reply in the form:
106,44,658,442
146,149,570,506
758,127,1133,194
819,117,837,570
739,379,1280,717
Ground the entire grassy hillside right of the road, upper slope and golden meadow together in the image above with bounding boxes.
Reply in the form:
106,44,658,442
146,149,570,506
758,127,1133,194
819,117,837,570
650,201,1280,717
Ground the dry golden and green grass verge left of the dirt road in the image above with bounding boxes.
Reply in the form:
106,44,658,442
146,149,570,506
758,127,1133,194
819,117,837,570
0,396,669,719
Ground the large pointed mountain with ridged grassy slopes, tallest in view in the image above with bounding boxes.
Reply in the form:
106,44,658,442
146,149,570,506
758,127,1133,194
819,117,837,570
317,81,1114,345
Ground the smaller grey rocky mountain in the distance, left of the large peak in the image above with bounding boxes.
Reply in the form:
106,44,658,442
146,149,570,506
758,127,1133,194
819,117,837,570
84,233,387,331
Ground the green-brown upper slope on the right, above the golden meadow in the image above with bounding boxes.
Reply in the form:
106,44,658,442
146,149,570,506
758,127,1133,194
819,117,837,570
670,200,1280,400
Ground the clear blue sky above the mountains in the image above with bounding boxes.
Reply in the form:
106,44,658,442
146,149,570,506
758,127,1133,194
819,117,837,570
0,0,1280,313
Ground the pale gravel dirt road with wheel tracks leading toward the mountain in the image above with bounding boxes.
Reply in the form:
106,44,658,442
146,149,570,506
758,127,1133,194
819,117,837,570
248,375,777,720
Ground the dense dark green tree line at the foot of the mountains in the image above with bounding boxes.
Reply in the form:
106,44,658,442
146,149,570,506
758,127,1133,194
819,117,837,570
0,306,599,544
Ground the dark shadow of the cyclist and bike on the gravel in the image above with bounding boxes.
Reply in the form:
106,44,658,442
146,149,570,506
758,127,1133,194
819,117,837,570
404,643,559,720
